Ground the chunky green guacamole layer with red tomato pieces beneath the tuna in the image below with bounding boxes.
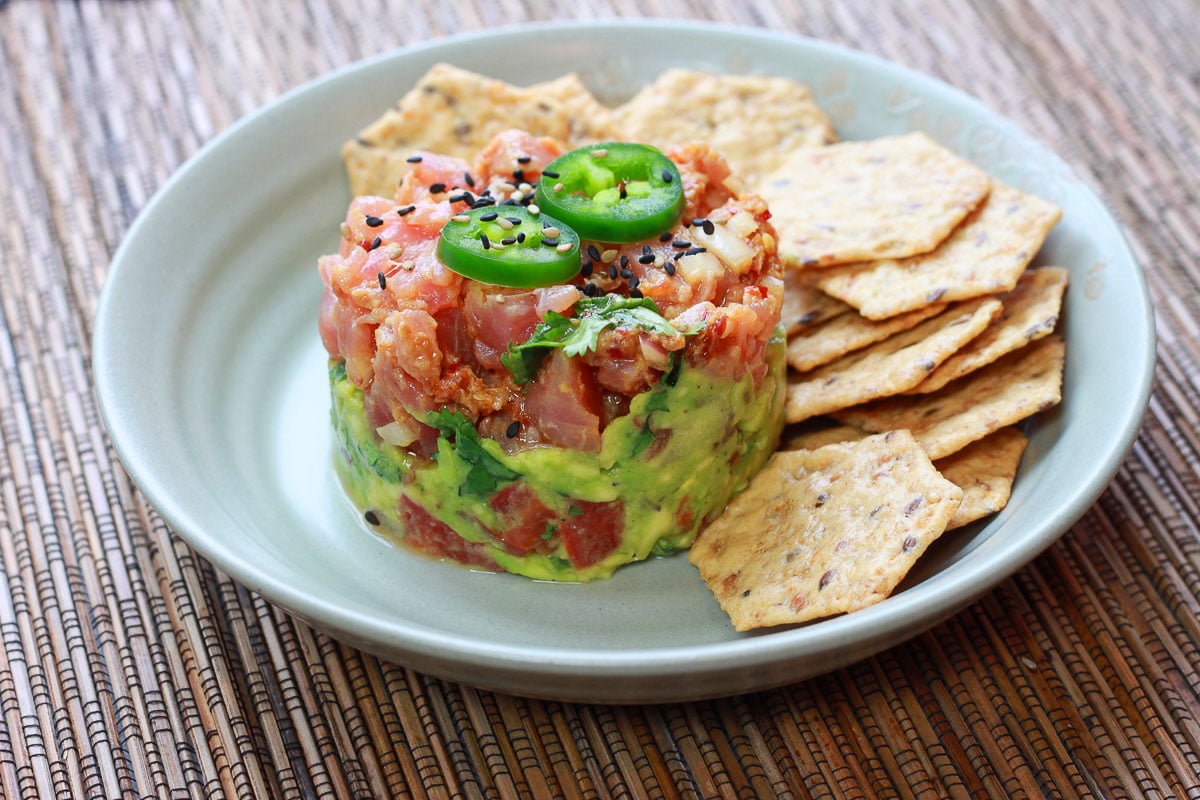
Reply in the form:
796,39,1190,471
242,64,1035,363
330,336,786,582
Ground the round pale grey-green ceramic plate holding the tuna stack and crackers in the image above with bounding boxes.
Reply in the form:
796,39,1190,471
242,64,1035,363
94,22,1153,702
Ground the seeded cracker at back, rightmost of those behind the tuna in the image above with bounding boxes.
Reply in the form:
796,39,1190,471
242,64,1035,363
614,70,835,187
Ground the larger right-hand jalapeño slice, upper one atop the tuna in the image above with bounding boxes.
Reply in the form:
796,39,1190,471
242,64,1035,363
536,142,684,242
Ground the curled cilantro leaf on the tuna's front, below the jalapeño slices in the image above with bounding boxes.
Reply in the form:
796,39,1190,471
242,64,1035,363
500,295,701,384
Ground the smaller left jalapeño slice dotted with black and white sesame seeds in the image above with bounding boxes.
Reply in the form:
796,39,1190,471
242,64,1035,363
438,205,580,289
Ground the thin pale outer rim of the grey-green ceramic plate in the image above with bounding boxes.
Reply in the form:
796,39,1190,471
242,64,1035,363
91,19,1156,700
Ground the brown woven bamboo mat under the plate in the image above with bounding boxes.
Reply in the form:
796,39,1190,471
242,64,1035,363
0,0,1200,798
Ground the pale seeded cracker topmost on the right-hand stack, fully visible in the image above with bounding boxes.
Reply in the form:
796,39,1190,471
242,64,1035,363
758,133,991,267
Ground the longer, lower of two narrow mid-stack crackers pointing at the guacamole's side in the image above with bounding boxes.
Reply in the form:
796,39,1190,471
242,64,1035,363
785,297,1001,431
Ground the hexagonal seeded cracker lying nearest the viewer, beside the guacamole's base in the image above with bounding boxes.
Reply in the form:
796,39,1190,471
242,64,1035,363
688,431,962,631
